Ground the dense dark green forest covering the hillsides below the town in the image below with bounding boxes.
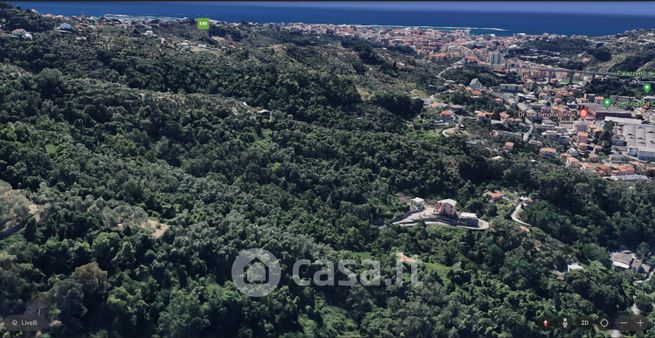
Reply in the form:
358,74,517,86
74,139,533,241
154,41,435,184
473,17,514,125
0,5,655,337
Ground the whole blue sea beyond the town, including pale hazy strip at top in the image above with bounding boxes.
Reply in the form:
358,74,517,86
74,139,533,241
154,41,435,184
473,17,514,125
10,1,655,36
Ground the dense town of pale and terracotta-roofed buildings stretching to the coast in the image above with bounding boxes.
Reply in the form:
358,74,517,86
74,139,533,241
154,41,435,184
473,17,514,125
281,23,655,180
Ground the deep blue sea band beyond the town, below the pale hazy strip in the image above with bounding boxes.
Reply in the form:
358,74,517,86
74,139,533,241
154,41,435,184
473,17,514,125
10,1,655,36
